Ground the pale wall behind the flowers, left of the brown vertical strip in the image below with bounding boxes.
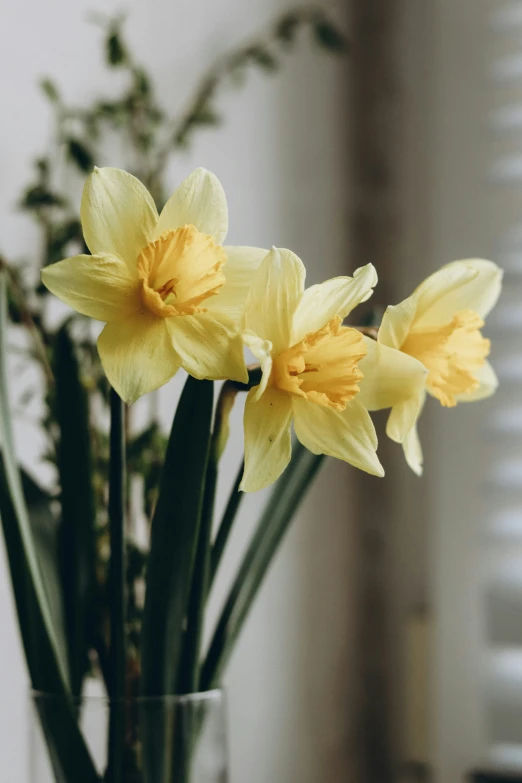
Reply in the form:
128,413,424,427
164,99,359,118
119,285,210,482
0,0,352,783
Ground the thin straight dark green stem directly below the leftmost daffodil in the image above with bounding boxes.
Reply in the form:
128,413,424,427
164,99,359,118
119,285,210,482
106,389,126,783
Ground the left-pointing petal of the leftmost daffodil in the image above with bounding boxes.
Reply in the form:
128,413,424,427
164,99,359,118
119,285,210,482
42,255,141,321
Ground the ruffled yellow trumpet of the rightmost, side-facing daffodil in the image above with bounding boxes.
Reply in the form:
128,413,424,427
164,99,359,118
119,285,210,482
401,310,490,408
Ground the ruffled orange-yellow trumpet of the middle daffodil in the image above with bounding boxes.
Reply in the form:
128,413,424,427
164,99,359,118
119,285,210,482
270,316,366,411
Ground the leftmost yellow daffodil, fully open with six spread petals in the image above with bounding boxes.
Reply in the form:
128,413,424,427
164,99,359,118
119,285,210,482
42,168,266,403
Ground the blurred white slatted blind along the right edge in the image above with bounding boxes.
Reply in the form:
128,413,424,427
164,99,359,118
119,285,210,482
481,0,522,770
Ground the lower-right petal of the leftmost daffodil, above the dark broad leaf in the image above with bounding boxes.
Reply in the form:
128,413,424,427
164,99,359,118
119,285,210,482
166,312,248,383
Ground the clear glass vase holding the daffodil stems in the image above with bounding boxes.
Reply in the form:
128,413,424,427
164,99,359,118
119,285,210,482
29,690,228,783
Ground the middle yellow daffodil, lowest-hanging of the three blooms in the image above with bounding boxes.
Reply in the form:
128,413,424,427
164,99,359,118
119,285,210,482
241,248,425,492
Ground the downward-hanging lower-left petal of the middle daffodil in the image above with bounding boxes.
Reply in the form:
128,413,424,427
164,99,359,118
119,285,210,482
240,388,292,492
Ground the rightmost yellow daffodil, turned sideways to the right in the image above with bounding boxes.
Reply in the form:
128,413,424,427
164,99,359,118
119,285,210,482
372,259,502,475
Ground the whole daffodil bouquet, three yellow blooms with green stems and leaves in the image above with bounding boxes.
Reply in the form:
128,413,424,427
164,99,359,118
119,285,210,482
0,168,502,783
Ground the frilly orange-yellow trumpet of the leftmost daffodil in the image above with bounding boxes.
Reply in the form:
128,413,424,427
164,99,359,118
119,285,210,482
137,226,226,318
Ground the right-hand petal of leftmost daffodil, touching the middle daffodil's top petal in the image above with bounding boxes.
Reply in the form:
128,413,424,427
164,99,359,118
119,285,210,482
206,247,268,323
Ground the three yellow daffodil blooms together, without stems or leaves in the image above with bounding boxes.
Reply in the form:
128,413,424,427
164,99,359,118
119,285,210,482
42,168,502,492
